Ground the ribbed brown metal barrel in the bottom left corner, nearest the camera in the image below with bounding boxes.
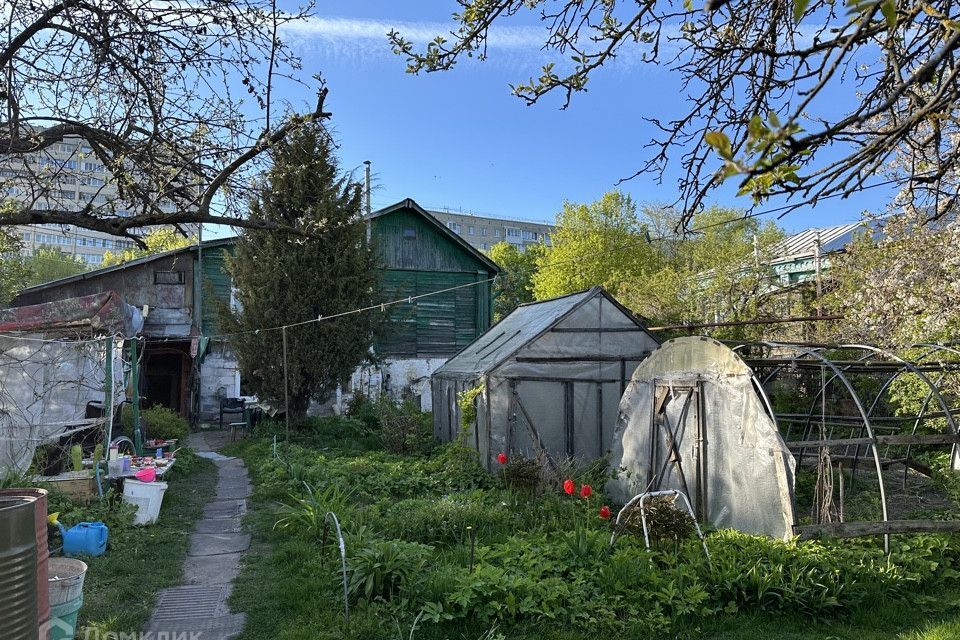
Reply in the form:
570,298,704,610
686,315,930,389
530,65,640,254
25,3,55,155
0,496,40,640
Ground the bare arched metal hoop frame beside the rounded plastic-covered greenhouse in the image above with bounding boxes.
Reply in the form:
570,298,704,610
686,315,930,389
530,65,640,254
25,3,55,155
733,342,960,548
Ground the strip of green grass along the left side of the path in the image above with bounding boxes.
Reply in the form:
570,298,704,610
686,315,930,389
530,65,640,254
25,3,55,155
51,453,217,637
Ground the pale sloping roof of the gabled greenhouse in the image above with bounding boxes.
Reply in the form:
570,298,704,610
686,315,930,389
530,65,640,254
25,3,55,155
434,286,652,375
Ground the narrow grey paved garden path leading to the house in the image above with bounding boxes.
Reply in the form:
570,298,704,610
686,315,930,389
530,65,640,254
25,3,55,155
146,432,252,640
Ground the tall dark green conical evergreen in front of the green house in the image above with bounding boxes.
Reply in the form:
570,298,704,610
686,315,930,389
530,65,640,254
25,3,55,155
221,125,378,417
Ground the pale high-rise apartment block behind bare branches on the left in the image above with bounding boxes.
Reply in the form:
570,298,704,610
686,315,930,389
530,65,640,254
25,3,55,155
0,136,182,266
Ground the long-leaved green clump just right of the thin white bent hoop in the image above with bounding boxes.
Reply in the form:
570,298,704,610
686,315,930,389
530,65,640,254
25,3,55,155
349,540,432,601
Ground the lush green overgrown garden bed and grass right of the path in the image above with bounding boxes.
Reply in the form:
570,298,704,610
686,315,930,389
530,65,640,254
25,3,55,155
223,408,960,640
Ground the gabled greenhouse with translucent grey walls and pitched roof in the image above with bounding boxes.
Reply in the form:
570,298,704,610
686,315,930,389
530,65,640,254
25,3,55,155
431,287,658,468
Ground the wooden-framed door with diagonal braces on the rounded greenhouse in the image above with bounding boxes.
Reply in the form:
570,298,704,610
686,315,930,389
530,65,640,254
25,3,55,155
647,380,710,522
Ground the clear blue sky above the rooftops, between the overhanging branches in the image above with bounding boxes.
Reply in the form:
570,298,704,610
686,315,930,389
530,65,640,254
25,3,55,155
231,0,890,230
